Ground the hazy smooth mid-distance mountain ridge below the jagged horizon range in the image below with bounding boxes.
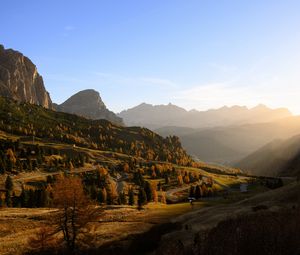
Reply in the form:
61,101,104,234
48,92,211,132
155,117,300,165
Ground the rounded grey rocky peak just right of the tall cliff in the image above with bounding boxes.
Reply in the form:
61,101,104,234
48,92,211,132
55,89,123,125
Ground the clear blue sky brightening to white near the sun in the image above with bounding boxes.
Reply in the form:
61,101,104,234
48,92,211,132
0,0,300,114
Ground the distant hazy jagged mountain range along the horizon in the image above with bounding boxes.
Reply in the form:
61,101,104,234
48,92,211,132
119,103,291,129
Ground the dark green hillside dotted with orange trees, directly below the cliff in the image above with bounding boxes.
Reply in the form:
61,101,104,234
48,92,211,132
0,97,191,165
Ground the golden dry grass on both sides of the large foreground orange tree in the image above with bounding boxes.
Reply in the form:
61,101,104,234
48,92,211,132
0,203,205,255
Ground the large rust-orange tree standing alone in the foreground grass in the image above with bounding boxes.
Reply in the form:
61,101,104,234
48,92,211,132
52,177,96,252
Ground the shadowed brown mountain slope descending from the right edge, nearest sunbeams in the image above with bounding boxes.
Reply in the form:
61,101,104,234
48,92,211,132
235,135,300,176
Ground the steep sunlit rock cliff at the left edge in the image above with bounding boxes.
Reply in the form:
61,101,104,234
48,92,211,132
0,45,52,109
